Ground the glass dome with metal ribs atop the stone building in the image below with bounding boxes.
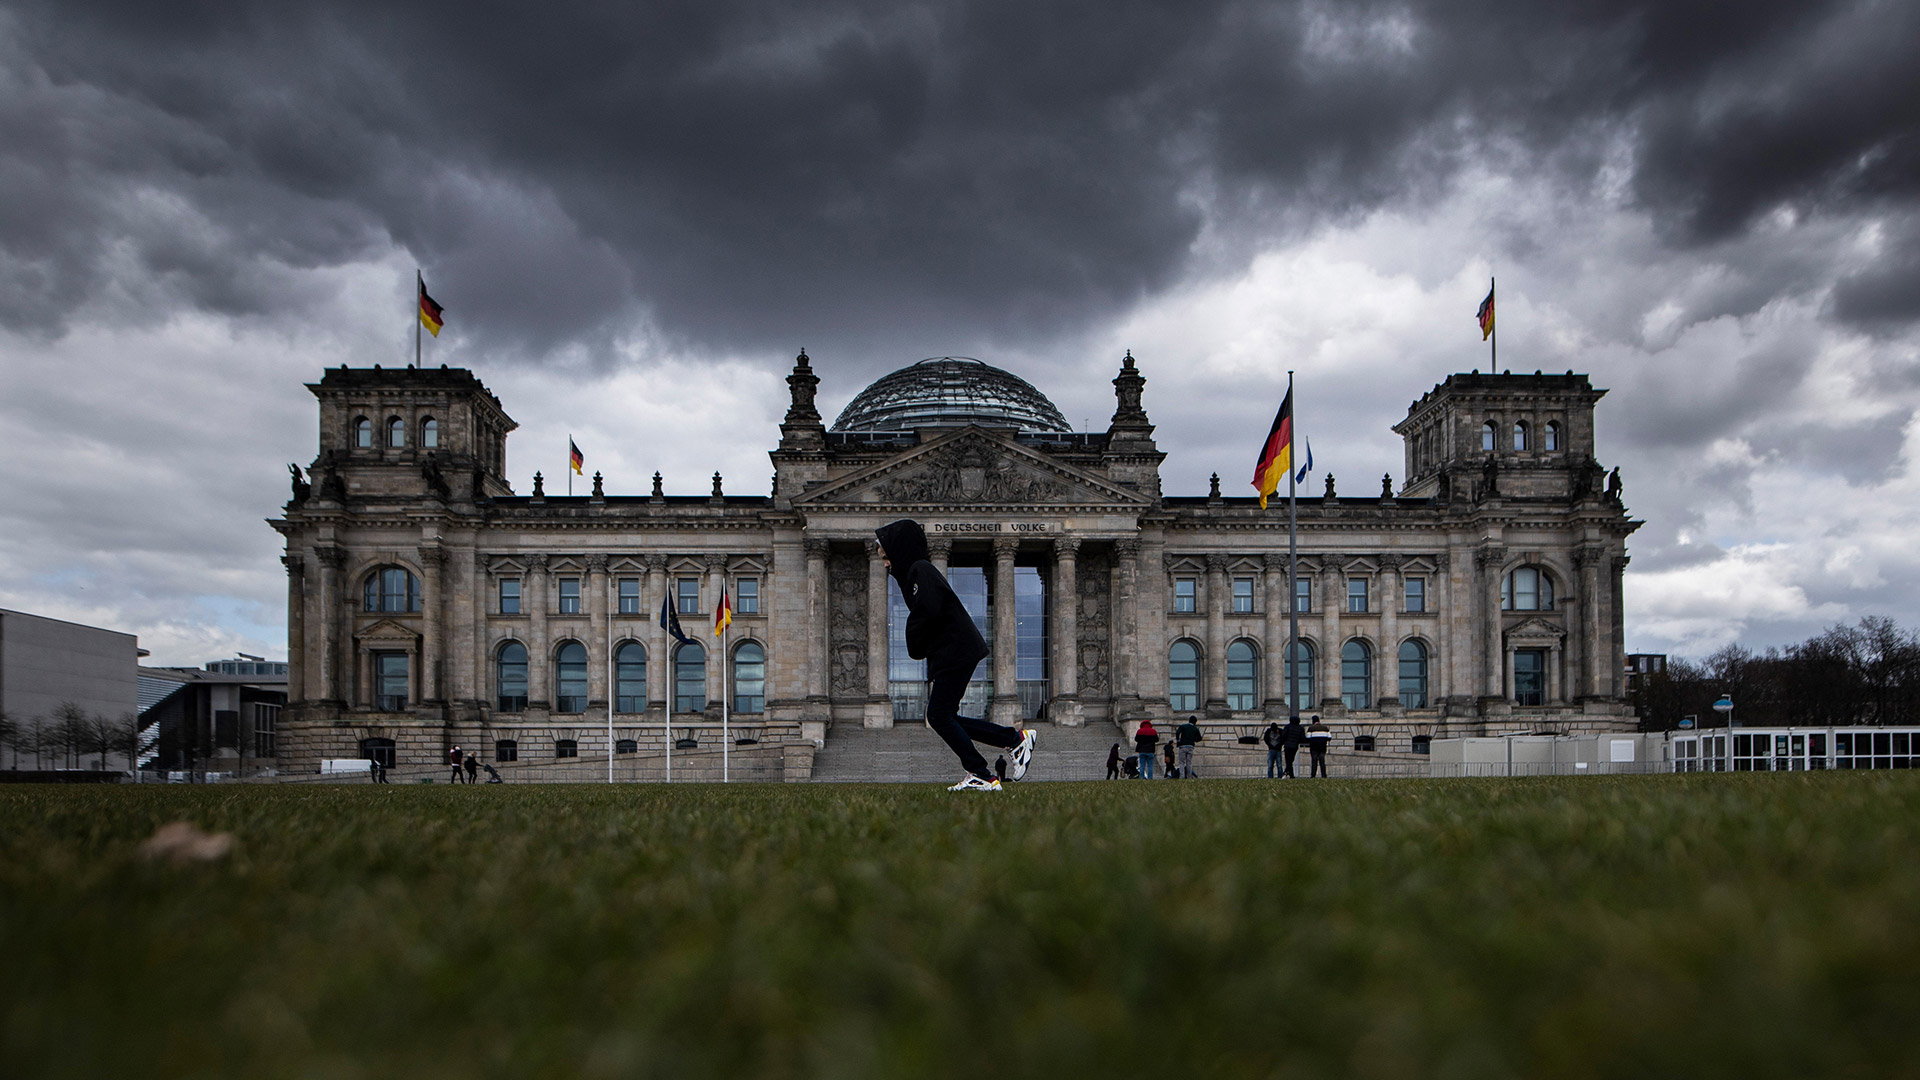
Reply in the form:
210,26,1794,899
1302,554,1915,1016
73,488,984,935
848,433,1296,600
833,356,1073,432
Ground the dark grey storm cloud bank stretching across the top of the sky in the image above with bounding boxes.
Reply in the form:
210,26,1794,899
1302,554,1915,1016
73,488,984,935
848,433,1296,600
0,0,1920,354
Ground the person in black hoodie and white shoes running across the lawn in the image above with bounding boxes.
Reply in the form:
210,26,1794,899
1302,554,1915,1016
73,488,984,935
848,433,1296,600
874,517,1035,792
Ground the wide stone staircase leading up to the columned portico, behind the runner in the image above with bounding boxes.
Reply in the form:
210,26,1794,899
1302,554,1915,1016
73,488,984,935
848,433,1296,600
814,721,1127,784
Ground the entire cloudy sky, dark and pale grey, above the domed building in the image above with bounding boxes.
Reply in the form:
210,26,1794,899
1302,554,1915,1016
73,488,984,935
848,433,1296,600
0,0,1920,663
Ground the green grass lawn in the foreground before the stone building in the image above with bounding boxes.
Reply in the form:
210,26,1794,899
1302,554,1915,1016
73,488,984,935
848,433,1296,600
0,773,1920,1080
